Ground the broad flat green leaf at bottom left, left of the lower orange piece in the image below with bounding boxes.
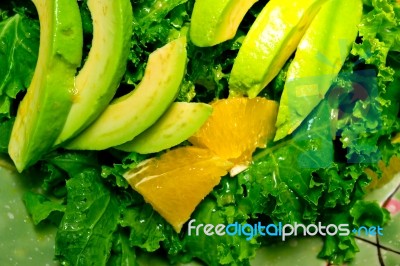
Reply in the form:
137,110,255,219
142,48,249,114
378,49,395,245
55,168,119,265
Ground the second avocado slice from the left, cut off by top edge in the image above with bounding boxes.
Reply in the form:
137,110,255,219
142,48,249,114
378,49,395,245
55,0,133,145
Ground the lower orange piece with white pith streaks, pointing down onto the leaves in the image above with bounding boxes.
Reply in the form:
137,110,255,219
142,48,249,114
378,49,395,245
124,147,233,232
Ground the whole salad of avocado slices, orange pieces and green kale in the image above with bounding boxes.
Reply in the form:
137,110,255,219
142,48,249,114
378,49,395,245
0,0,400,265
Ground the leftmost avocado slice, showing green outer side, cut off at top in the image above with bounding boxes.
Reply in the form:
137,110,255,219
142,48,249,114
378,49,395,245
8,0,83,172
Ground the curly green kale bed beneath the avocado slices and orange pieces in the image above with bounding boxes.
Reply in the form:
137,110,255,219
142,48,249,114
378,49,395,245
0,0,400,265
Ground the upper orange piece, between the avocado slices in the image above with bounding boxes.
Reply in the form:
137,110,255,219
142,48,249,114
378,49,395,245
189,97,278,165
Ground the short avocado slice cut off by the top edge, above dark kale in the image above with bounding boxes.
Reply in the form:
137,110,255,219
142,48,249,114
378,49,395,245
190,0,258,47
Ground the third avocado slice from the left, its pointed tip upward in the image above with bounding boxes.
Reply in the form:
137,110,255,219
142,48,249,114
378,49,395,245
66,37,187,150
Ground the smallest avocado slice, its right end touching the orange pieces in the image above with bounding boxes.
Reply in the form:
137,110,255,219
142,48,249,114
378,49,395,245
116,102,212,154
